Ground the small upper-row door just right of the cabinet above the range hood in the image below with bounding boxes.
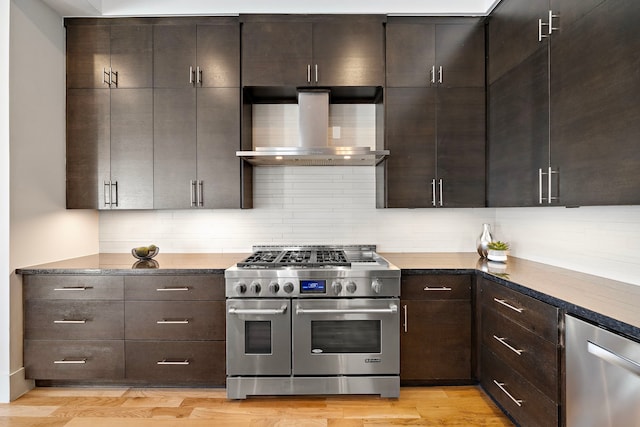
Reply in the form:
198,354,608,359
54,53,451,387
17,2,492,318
386,18,436,87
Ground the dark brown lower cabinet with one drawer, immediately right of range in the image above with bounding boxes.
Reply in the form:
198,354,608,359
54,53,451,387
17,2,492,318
400,273,472,385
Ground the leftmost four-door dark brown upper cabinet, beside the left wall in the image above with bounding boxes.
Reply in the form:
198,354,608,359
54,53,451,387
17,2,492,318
65,19,153,209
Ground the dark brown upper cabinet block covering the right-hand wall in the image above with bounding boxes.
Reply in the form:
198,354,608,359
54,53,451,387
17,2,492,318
488,0,640,206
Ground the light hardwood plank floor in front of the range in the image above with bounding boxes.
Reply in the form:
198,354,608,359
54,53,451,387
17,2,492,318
0,386,513,427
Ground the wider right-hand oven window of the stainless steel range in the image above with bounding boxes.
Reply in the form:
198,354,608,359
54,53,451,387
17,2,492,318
311,320,381,353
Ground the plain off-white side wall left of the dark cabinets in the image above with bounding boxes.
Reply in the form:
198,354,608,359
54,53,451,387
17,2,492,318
0,0,98,400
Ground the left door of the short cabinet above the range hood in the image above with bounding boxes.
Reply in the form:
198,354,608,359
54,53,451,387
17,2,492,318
242,22,312,86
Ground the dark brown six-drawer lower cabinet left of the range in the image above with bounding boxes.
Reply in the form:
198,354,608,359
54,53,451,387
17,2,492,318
24,274,226,386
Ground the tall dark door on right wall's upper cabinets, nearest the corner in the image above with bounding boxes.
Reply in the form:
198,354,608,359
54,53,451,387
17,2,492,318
488,49,549,206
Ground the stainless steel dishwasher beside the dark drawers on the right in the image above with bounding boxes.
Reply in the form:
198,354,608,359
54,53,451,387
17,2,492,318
565,315,640,427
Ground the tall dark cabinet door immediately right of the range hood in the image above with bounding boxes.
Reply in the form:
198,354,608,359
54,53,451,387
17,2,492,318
385,88,436,208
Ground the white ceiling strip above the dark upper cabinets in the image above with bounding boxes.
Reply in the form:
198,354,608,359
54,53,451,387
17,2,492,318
42,0,499,17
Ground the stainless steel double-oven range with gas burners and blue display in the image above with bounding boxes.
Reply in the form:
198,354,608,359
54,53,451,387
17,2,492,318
225,245,400,399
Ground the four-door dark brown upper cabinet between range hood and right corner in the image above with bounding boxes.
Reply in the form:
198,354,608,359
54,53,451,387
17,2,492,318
384,17,485,208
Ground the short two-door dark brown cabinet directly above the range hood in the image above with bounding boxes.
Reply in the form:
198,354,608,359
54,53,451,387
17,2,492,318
241,15,385,101
